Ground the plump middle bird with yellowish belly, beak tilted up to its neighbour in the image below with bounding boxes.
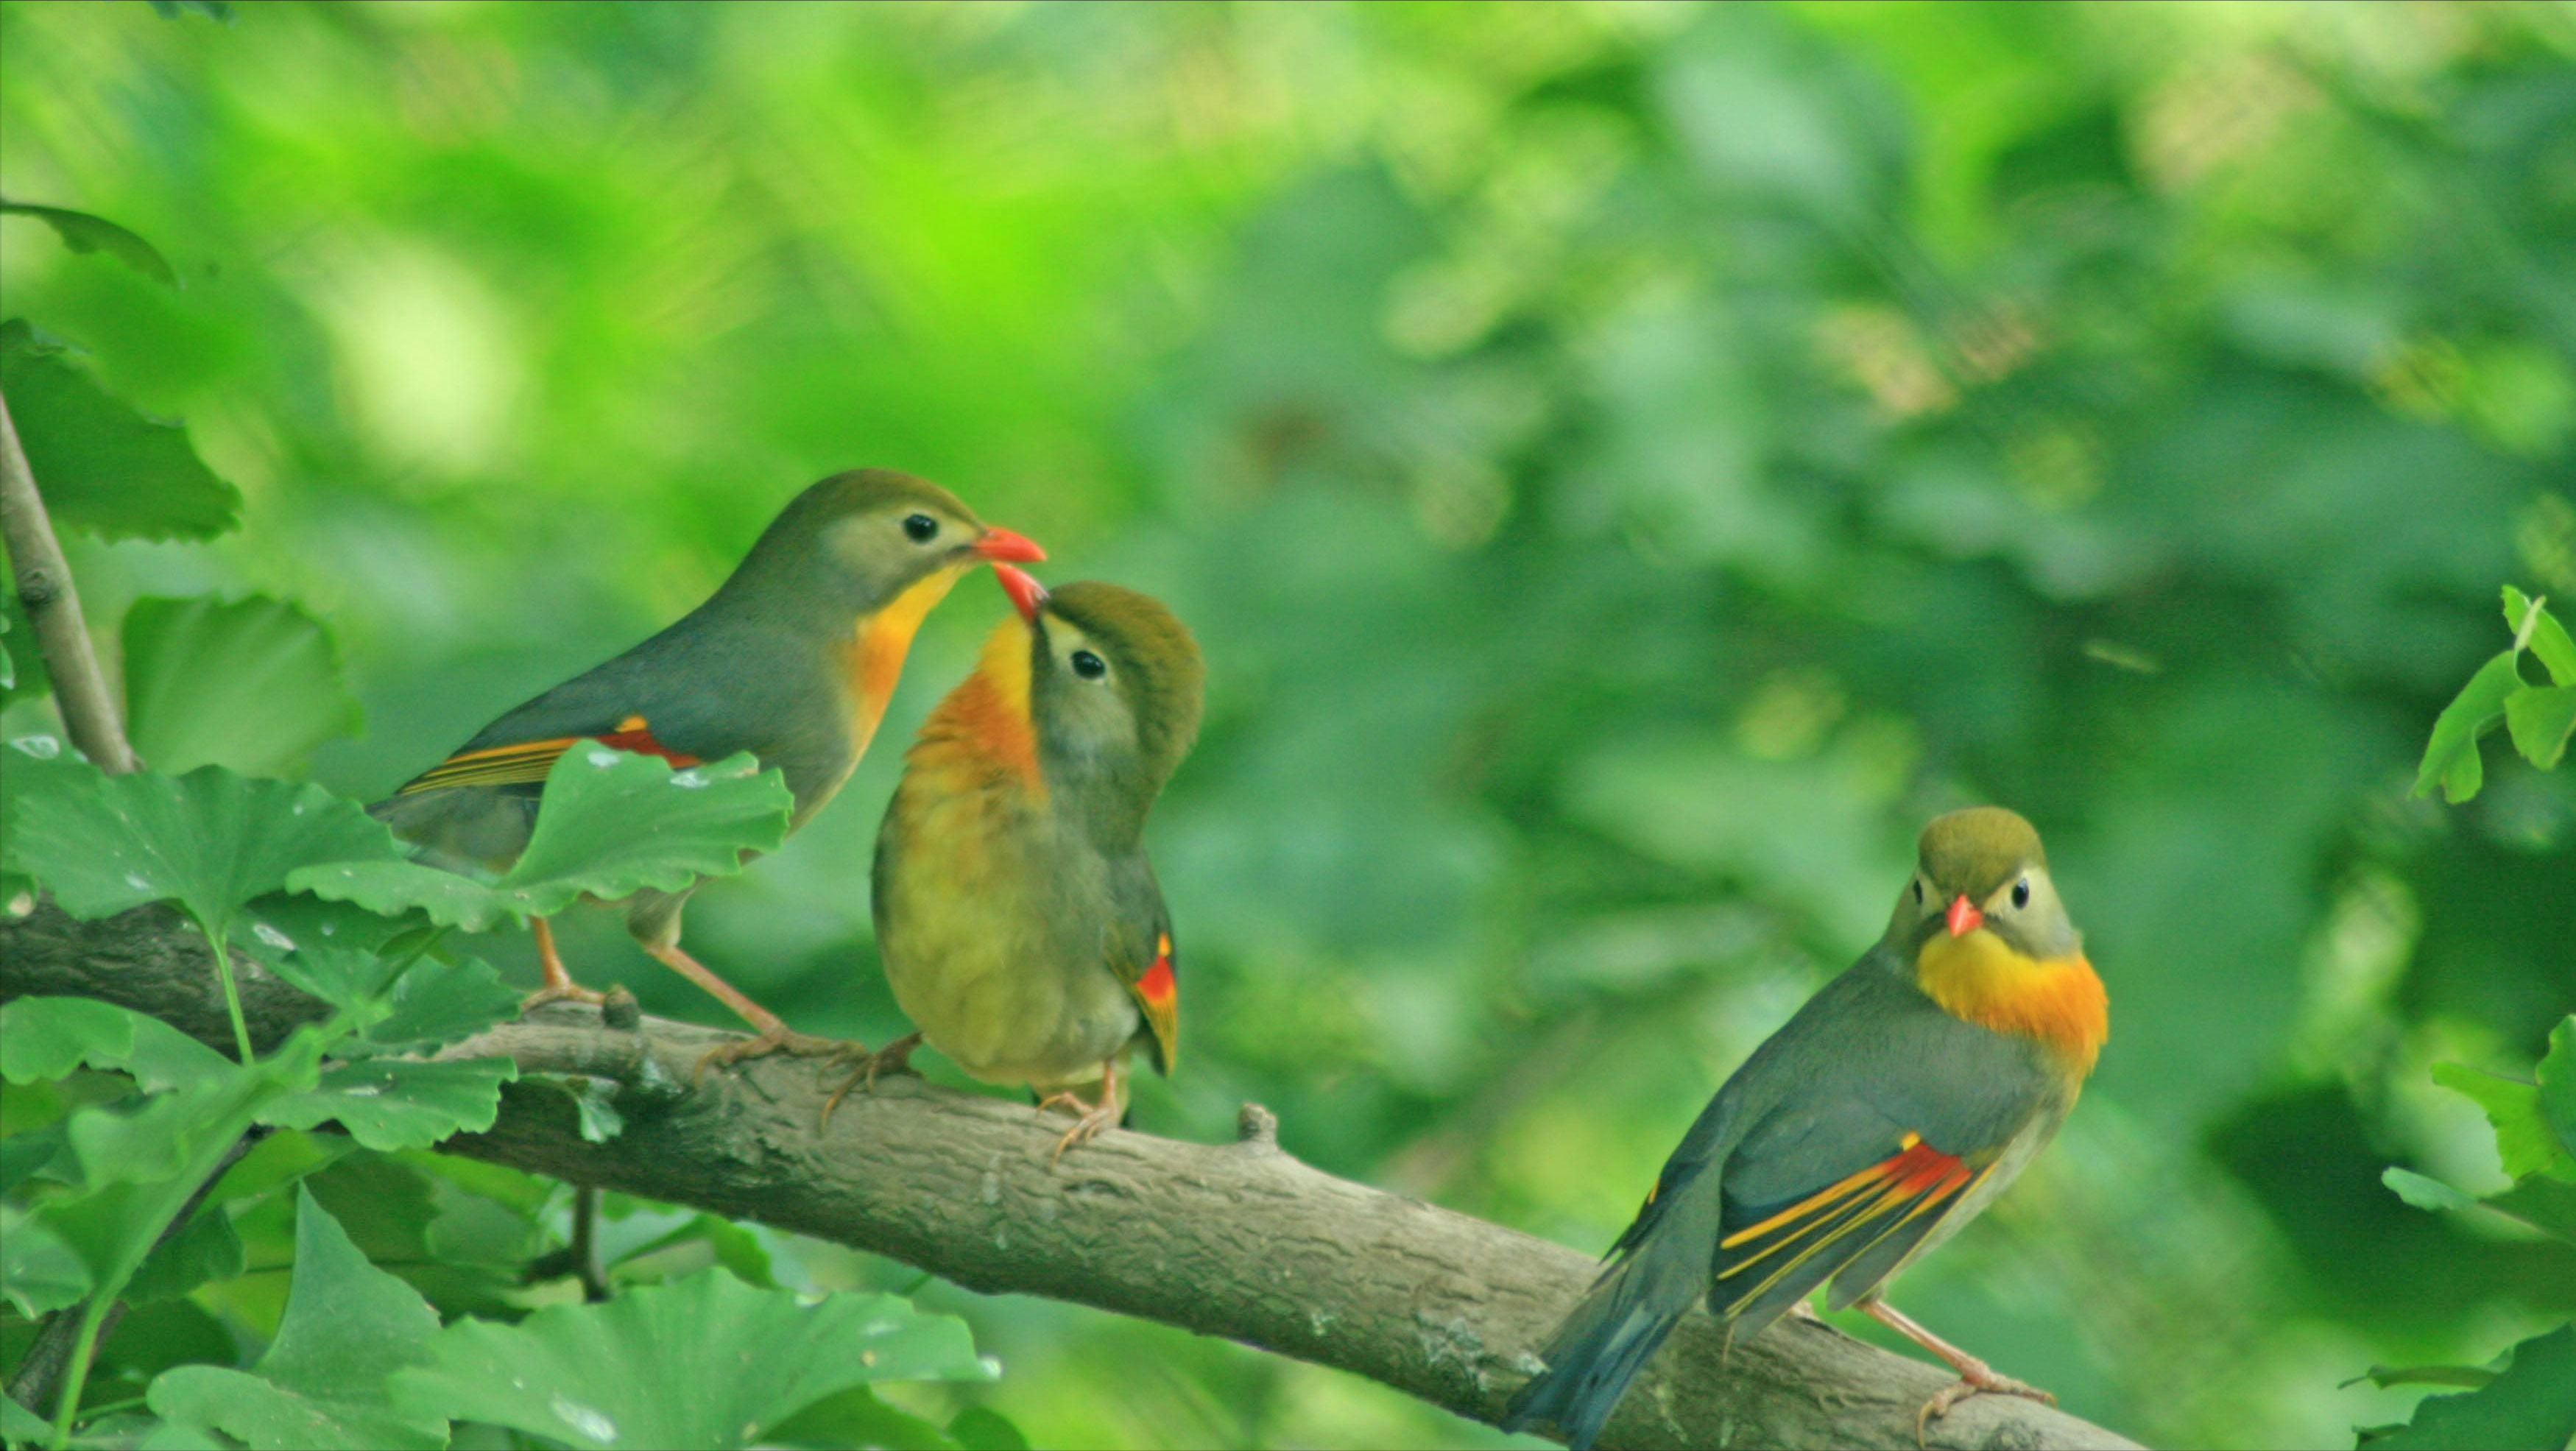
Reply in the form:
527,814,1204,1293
835,567,1206,1154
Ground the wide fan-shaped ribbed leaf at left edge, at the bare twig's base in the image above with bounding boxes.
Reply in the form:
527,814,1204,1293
10,766,399,953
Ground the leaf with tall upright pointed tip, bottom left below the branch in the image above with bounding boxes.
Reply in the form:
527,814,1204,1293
147,1188,448,1451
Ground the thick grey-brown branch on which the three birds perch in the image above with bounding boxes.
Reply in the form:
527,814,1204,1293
0,902,2133,1451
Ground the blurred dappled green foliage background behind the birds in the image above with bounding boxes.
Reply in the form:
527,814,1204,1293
0,3,2576,1446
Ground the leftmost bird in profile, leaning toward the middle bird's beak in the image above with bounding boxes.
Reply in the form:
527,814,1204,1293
368,469,1046,1062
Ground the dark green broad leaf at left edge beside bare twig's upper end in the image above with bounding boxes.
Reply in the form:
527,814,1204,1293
0,317,242,539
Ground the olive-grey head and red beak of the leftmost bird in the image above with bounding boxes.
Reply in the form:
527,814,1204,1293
727,469,1046,626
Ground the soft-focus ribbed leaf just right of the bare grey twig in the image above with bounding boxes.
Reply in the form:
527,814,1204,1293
124,596,366,776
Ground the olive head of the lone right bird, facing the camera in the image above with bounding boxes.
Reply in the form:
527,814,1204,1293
1888,807,2081,961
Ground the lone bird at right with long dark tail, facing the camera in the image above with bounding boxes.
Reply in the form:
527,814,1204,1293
1504,807,2110,1448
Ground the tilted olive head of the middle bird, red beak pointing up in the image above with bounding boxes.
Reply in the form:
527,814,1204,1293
1005,575,1208,830
